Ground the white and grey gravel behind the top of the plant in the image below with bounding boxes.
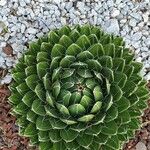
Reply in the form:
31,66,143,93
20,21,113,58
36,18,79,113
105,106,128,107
0,0,150,84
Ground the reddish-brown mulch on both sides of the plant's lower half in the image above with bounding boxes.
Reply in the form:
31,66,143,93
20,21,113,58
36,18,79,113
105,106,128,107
0,82,150,150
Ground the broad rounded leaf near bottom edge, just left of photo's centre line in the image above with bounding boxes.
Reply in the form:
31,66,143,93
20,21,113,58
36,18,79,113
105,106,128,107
60,128,79,143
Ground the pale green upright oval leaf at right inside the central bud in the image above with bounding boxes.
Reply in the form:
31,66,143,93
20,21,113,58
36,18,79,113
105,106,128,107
93,86,103,102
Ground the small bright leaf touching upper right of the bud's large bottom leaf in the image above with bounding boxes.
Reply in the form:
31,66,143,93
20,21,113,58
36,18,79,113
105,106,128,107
80,95,92,108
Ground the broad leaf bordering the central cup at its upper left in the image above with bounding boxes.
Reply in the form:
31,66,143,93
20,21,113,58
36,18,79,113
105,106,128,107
60,55,76,68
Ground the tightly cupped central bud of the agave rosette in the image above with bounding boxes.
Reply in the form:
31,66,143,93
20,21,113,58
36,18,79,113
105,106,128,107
51,67,103,122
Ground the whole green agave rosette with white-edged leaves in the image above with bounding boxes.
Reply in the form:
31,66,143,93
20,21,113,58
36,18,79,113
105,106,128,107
9,25,149,150
